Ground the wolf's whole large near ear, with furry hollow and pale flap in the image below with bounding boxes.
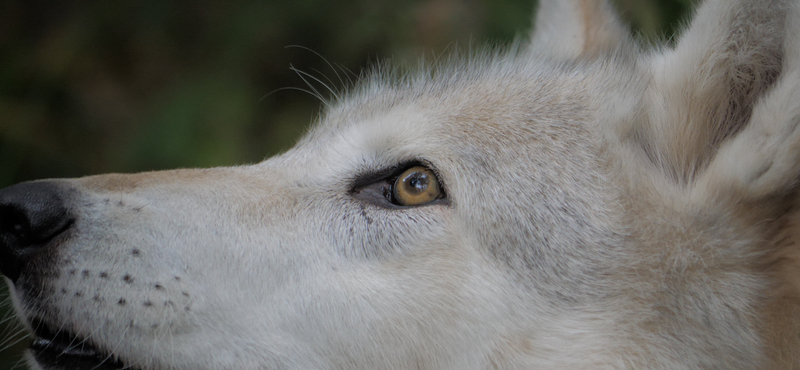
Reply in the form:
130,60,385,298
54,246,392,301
633,0,800,202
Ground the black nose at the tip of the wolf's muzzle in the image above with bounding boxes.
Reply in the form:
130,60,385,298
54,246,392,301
0,181,72,281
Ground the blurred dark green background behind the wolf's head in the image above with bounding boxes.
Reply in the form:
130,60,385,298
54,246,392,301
0,0,692,370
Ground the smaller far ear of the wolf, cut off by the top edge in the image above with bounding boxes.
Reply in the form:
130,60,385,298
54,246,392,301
531,0,630,59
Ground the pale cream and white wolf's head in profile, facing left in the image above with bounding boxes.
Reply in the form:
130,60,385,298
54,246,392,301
0,0,800,370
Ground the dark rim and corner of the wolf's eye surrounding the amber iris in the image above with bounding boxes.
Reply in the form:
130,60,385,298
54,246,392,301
350,160,450,209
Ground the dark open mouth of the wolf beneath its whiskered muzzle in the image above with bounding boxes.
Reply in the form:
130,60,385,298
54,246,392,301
30,320,132,370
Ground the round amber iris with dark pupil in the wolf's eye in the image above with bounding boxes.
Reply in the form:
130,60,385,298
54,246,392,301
392,166,442,206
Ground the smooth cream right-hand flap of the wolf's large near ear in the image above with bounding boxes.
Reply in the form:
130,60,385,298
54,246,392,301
695,1,800,200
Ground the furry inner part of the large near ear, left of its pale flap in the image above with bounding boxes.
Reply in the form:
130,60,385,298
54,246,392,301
644,0,796,184
